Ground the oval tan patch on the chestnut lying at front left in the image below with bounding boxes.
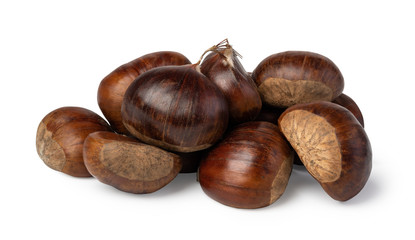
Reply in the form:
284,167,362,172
100,142,174,181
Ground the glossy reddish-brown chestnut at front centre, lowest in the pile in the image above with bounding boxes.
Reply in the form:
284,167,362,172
198,122,293,208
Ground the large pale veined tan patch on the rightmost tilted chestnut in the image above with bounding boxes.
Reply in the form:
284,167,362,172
280,110,342,183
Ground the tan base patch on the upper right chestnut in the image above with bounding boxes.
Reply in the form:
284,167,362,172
258,78,333,107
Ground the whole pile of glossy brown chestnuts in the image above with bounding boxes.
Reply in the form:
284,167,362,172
36,40,372,208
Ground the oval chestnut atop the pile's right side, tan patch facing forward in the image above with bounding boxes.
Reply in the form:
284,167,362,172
252,51,344,108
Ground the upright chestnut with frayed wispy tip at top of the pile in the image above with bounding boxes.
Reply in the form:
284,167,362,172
200,41,262,124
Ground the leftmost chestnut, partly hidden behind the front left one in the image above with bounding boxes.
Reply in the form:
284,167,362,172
36,107,112,177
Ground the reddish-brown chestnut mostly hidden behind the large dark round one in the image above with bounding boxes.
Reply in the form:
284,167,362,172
97,51,190,135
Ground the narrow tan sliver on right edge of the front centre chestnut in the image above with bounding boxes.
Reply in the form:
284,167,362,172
270,154,294,204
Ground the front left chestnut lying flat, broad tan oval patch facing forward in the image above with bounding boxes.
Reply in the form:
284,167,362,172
83,132,182,193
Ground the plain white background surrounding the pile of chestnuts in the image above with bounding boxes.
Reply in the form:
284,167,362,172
0,0,415,239
